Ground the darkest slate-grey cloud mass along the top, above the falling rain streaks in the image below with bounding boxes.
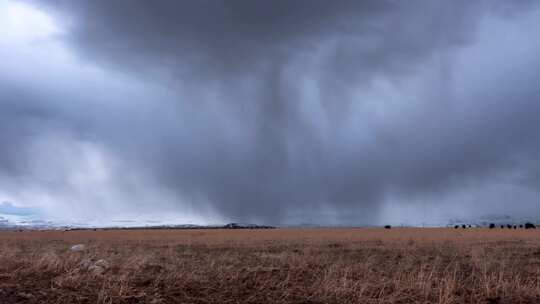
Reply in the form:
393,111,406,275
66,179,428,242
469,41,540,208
38,0,486,83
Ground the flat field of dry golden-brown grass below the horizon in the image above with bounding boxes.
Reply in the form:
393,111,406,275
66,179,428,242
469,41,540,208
0,228,540,304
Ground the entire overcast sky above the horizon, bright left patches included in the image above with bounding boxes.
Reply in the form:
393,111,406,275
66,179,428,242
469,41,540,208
0,0,540,225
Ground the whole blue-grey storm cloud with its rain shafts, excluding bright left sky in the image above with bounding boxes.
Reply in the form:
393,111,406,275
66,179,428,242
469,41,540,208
0,0,540,223
